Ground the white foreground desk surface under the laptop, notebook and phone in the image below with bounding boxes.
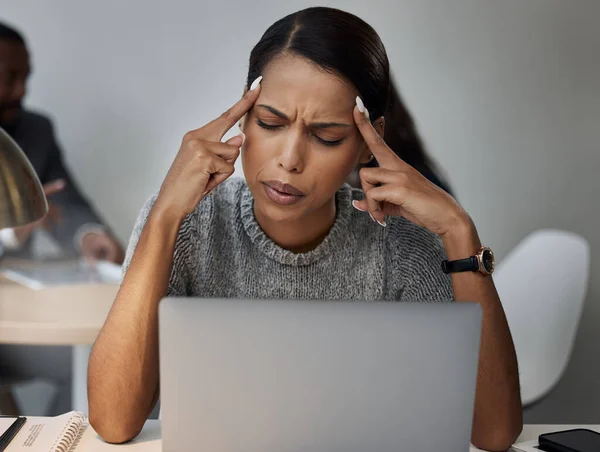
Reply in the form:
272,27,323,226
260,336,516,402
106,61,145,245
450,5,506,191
68,420,600,452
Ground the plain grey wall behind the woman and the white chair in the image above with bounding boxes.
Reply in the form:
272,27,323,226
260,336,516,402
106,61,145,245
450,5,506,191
0,0,600,423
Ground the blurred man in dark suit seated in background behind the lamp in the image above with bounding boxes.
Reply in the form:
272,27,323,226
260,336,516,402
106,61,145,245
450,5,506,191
0,22,124,264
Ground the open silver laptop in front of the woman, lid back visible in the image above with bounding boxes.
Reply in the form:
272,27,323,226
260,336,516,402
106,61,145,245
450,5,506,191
159,298,481,452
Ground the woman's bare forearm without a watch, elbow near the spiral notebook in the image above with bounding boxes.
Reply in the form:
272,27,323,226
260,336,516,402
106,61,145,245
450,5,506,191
88,209,180,442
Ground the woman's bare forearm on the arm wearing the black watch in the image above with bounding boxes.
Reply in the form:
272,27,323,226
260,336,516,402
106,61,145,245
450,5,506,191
443,222,523,450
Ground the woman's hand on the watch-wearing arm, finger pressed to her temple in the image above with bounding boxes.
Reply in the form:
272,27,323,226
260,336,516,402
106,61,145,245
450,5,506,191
353,100,470,237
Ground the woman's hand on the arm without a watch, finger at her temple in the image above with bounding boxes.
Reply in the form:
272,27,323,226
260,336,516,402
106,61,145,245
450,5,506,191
154,78,260,220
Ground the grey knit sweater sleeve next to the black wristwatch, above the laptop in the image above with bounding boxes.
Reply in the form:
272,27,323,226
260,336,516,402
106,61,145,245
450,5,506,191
388,218,454,302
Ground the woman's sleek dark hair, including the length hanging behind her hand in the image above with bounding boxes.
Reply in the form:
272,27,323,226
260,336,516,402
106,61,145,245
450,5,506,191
246,7,447,194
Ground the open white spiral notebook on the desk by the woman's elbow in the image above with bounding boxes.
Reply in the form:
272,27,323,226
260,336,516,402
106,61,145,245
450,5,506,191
6,411,88,452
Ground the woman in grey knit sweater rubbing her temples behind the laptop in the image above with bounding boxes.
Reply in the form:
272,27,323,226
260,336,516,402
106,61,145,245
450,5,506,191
88,8,522,450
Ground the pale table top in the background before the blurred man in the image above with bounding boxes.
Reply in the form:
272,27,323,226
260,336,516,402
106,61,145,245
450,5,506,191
0,264,118,345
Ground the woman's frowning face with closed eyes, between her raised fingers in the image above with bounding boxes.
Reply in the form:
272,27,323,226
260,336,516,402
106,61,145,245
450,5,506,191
242,55,370,221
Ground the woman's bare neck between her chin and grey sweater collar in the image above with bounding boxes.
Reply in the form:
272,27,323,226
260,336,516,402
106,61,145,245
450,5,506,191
254,196,336,253
